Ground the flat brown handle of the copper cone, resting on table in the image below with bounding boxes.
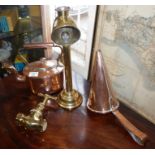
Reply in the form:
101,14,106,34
113,110,147,145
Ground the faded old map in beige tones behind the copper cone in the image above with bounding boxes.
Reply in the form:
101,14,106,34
100,6,155,123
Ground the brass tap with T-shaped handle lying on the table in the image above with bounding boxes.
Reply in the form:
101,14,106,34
16,93,57,132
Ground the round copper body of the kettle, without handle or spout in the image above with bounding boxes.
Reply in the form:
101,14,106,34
23,59,64,94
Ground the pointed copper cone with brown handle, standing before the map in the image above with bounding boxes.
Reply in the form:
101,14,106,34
87,51,147,145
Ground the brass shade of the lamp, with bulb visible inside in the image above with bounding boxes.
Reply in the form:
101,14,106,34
52,7,80,46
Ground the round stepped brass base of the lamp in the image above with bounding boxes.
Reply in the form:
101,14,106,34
58,89,83,110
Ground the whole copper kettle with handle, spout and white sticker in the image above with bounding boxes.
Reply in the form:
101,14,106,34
4,43,64,94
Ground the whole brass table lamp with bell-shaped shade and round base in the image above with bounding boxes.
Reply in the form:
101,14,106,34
52,6,82,110
